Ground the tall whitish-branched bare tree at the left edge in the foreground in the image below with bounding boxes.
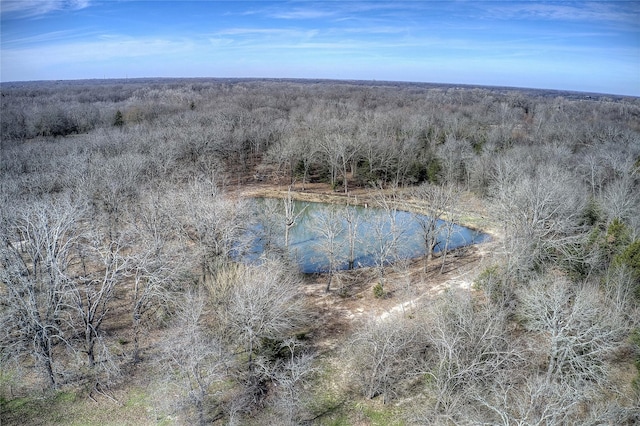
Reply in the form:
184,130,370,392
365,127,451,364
0,197,82,387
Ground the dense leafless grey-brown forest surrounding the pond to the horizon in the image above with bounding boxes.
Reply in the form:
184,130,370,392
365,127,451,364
0,79,640,425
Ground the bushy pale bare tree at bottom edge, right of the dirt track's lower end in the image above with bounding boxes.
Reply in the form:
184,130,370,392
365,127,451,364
423,293,523,422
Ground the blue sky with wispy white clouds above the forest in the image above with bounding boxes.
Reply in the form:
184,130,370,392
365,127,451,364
0,0,640,96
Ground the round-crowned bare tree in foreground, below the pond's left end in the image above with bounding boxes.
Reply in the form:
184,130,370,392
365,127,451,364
196,260,306,415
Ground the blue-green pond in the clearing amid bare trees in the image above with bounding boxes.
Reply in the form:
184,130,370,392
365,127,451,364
244,198,489,273
